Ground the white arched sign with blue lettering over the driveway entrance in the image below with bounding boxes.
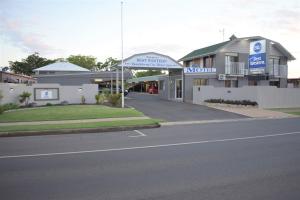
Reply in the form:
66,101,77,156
116,52,183,70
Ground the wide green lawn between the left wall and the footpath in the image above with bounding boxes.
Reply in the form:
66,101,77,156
0,105,143,122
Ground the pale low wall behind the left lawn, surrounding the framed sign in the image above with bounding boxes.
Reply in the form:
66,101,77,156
0,83,98,105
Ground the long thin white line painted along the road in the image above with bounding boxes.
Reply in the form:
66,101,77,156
0,131,300,159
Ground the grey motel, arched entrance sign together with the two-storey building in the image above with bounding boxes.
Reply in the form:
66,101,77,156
123,35,295,103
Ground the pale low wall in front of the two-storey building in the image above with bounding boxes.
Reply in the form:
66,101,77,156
193,86,300,108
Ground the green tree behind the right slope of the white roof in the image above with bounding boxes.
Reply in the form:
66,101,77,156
67,55,96,70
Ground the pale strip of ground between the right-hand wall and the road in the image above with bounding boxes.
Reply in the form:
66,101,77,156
207,105,299,118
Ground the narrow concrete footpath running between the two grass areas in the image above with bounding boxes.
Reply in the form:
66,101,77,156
0,116,149,127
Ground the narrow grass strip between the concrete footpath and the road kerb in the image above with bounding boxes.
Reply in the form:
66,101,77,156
0,119,158,135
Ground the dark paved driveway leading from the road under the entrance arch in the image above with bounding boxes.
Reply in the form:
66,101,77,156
125,93,246,121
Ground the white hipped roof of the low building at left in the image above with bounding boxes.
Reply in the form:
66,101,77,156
33,62,90,72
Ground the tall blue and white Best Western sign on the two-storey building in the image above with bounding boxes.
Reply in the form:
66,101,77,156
248,40,266,74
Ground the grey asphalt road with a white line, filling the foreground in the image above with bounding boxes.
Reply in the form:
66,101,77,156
0,118,300,200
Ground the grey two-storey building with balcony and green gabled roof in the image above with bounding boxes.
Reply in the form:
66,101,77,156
179,35,295,102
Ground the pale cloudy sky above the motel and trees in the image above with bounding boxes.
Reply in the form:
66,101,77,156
0,0,300,78
